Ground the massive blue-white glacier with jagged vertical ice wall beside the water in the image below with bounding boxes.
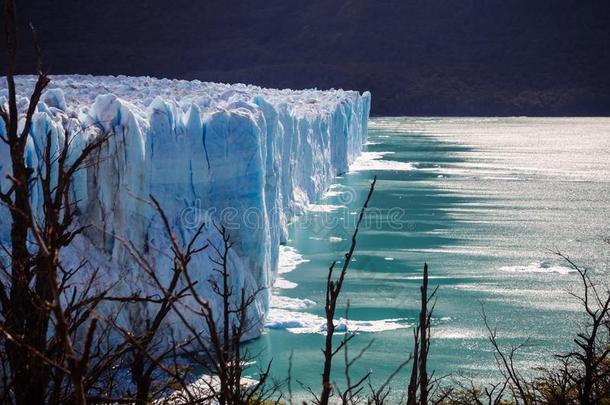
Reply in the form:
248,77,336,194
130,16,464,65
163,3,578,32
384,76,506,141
0,75,370,334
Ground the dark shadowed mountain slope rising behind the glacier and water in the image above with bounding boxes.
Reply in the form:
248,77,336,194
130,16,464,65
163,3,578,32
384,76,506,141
4,0,610,115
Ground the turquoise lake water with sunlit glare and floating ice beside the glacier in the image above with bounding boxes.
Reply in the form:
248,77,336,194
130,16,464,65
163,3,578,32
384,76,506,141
250,118,610,396
